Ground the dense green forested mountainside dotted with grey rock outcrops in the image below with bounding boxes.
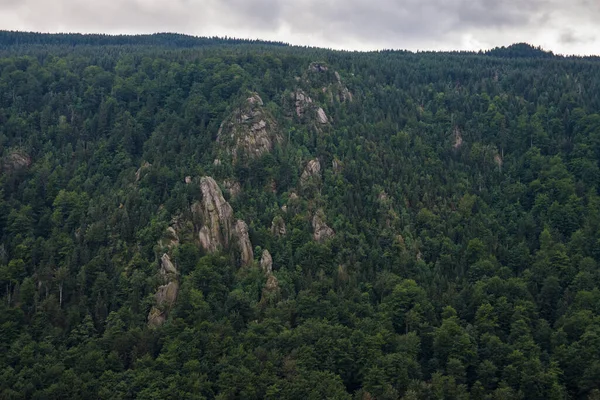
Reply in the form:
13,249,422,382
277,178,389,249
0,32,600,400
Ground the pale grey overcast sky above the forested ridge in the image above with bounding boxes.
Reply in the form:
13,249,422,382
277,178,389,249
0,0,600,54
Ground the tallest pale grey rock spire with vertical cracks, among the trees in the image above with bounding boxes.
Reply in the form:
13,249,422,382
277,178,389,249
192,177,233,253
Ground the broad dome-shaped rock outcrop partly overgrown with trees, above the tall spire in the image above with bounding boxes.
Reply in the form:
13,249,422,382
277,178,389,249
217,93,281,161
